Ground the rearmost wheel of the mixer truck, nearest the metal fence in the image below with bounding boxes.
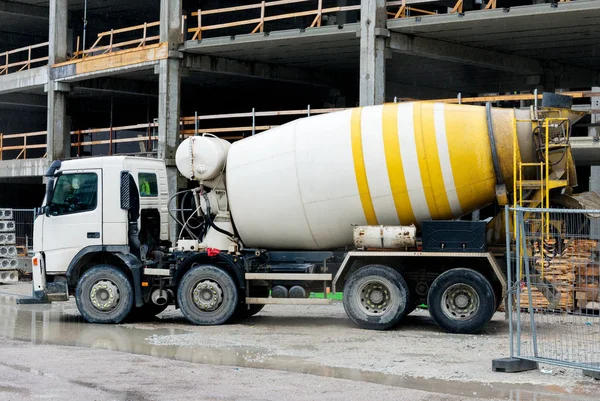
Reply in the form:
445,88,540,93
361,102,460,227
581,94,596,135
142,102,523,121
427,268,496,334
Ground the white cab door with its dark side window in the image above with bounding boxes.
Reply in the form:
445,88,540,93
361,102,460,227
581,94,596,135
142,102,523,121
42,169,102,273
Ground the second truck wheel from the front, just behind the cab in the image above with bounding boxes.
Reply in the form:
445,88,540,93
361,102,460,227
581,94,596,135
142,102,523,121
177,265,238,326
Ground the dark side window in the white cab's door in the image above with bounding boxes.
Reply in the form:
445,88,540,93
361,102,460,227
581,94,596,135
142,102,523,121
49,173,98,216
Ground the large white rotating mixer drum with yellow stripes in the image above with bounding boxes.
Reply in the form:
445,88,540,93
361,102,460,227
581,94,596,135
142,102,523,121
227,103,531,249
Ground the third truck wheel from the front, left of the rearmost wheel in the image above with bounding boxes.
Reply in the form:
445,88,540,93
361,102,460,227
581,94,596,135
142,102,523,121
343,265,410,330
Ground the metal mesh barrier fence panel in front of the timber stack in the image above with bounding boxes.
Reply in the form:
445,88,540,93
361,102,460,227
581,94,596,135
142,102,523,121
506,208,600,377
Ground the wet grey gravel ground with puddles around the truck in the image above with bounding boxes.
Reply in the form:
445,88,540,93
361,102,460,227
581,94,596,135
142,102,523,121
0,284,600,400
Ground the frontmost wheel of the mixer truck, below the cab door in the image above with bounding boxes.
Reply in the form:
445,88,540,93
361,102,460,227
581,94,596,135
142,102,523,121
75,265,133,323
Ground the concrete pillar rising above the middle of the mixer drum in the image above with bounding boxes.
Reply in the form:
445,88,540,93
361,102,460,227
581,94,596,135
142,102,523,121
360,0,389,106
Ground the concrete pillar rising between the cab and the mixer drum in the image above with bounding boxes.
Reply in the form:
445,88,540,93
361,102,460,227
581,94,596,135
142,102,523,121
158,0,182,243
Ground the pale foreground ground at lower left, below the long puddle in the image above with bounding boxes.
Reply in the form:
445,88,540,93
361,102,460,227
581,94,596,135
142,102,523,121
0,340,480,401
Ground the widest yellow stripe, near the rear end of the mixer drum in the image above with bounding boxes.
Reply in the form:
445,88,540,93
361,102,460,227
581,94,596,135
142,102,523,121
444,104,495,213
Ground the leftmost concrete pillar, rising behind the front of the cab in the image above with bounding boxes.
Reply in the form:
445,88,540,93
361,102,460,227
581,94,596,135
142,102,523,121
45,0,71,160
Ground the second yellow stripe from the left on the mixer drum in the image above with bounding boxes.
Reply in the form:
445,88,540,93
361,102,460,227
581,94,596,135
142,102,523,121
382,104,415,225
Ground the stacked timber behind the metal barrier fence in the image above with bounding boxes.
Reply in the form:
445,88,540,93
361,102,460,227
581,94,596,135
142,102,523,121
520,239,598,311
